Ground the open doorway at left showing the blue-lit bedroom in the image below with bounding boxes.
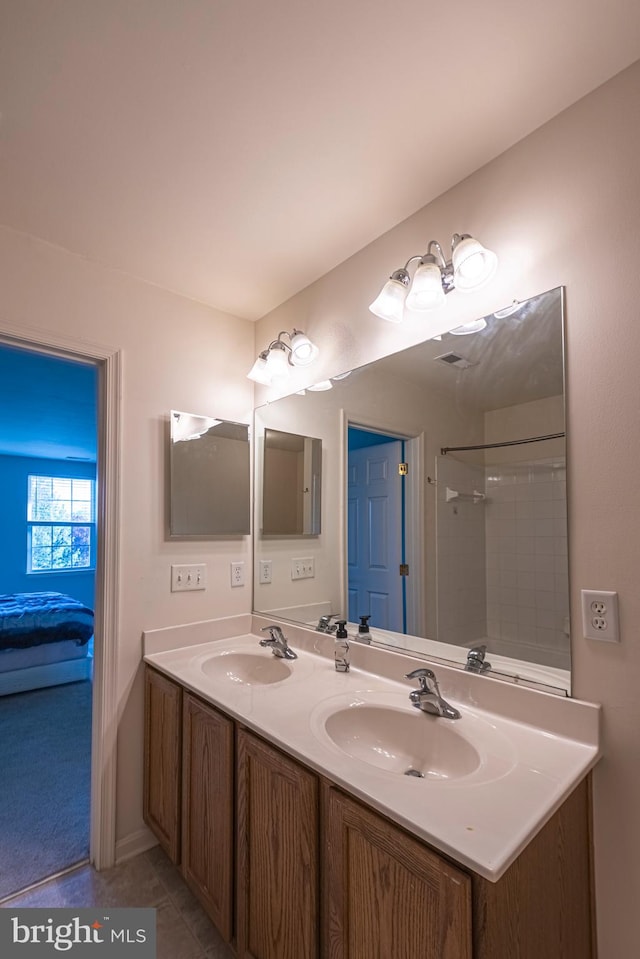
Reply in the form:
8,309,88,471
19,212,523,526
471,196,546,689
0,345,98,899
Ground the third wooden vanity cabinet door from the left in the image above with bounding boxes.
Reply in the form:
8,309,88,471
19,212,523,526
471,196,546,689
237,729,318,959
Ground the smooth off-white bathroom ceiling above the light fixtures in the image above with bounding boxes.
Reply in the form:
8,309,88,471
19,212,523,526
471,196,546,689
0,0,640,319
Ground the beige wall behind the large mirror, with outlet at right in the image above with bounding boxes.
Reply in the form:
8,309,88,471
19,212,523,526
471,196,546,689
258,63,640,959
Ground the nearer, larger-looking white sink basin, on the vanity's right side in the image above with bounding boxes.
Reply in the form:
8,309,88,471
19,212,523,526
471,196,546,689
311,691,516,785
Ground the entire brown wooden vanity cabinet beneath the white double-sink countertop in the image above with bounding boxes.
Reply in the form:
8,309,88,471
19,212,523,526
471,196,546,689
144,667,595,959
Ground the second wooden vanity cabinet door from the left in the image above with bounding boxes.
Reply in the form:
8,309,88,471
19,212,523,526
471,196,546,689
182,692,234,941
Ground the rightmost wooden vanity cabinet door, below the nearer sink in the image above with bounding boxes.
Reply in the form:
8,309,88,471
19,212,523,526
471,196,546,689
323,786,471,959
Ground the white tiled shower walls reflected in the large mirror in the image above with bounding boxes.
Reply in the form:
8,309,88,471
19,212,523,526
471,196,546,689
437,456,569,669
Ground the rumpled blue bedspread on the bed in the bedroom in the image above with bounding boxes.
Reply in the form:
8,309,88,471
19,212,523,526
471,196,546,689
0,593,93,649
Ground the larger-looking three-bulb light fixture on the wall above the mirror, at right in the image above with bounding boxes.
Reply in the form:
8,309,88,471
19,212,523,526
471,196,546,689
369,233,498,323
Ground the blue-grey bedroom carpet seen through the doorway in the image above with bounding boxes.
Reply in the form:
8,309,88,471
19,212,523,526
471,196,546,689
0,681,92,899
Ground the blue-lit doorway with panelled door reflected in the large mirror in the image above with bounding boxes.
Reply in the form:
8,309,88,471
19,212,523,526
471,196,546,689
347,426,406,633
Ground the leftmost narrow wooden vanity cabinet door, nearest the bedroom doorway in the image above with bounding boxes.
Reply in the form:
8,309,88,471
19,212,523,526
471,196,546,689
143,666,182,865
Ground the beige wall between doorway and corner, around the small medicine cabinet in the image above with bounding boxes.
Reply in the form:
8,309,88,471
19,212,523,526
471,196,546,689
0,229,254,852
